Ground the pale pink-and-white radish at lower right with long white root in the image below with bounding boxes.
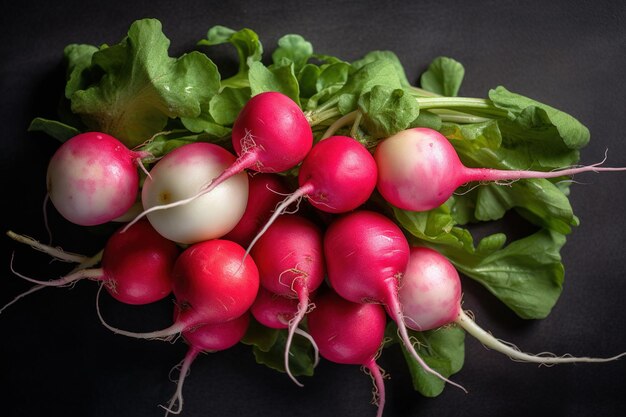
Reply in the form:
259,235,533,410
398,247,626,365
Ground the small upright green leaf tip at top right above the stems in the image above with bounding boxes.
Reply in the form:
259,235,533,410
420,56,465,97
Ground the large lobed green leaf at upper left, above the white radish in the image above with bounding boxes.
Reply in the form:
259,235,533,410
71,19,219,147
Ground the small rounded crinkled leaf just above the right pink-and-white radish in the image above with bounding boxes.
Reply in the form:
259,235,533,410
357,85,419,138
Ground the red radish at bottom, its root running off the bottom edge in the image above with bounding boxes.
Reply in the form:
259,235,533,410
308,291,387,417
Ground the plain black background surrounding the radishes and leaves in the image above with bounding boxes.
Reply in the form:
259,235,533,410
0,0,626,417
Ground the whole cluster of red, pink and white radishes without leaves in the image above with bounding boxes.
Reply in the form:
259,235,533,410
6,88,623,416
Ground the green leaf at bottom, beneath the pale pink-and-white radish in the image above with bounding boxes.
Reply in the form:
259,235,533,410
386,323,465,397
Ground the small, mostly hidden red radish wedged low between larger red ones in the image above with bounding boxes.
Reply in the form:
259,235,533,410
250,287,319,366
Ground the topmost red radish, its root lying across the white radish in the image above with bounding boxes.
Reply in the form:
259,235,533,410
127,91,313,221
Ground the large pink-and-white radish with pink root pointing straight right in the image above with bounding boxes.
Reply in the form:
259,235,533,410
374,128,626,211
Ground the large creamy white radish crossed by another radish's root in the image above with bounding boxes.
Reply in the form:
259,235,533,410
129,142,248,244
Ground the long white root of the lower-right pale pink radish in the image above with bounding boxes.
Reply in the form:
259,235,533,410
455,310,626,365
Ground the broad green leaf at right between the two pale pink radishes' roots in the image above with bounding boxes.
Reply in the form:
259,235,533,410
394,204,565,319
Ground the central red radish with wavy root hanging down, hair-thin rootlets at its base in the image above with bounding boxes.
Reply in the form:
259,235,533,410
251,215,325,385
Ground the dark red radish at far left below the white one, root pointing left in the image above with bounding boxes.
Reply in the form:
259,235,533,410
6,220,179,305
